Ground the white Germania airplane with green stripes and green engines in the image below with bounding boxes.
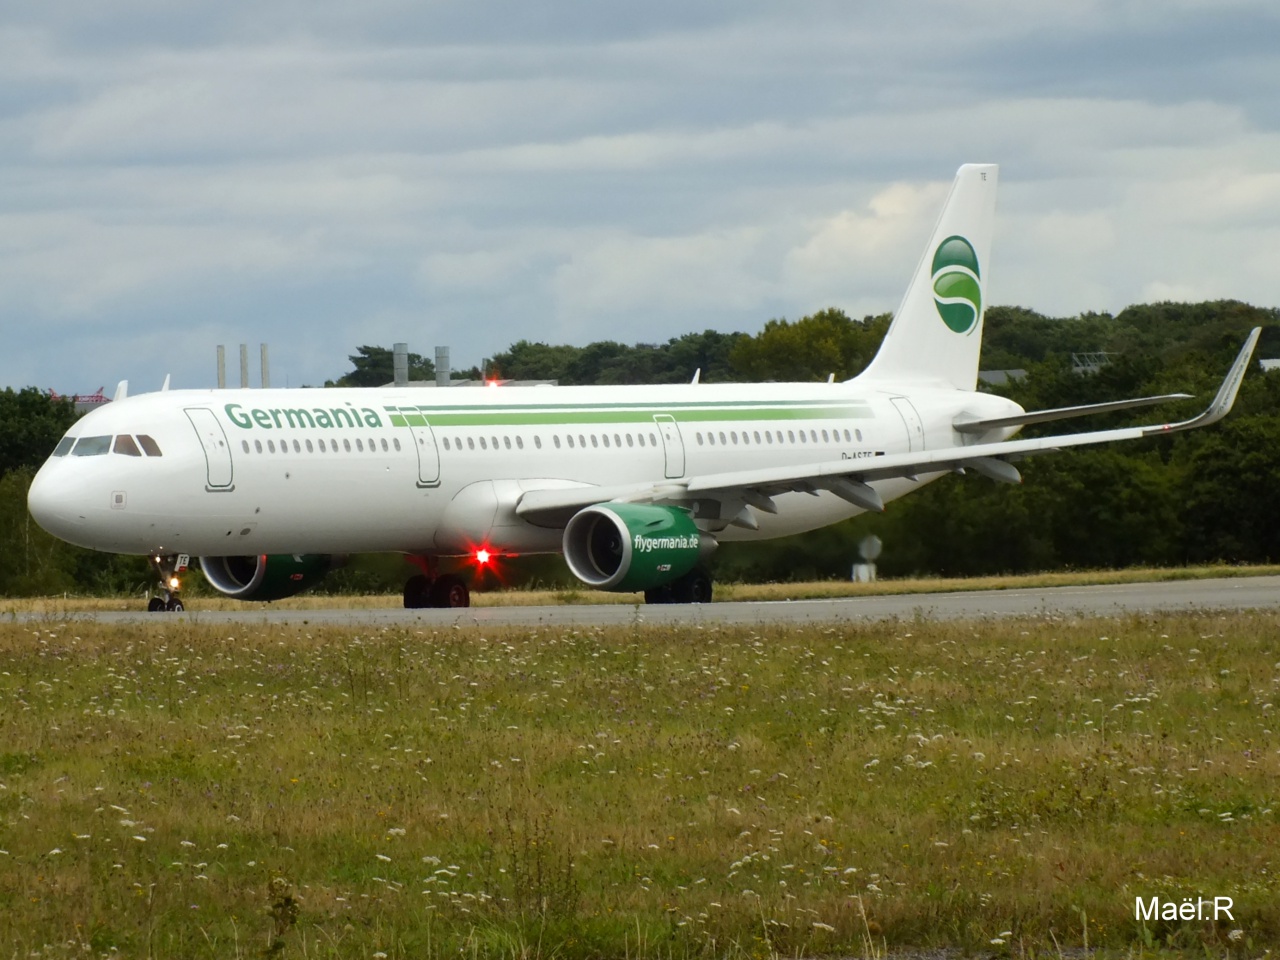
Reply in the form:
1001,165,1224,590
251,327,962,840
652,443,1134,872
28,164,1258,611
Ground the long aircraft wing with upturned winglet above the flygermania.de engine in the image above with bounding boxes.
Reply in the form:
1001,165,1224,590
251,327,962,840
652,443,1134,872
516,328,1261,526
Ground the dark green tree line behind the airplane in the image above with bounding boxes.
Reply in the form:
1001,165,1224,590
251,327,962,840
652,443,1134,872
0,301,1280,595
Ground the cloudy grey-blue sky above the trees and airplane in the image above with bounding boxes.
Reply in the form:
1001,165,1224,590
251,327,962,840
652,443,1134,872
0,0,1280,392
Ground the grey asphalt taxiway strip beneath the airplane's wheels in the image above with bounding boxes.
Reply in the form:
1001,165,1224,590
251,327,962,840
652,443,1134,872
9,576,1280,627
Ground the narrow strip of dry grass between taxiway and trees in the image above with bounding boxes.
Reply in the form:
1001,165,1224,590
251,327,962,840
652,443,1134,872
0,564,1280,616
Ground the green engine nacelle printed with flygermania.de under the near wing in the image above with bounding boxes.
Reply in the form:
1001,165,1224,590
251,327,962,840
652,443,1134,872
563,503,716,593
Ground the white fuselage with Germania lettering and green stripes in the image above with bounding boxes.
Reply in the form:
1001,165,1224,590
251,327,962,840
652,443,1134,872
22,380,1018,556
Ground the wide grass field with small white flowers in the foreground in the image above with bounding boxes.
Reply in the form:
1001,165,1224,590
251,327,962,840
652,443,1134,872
0,613,1280,960
